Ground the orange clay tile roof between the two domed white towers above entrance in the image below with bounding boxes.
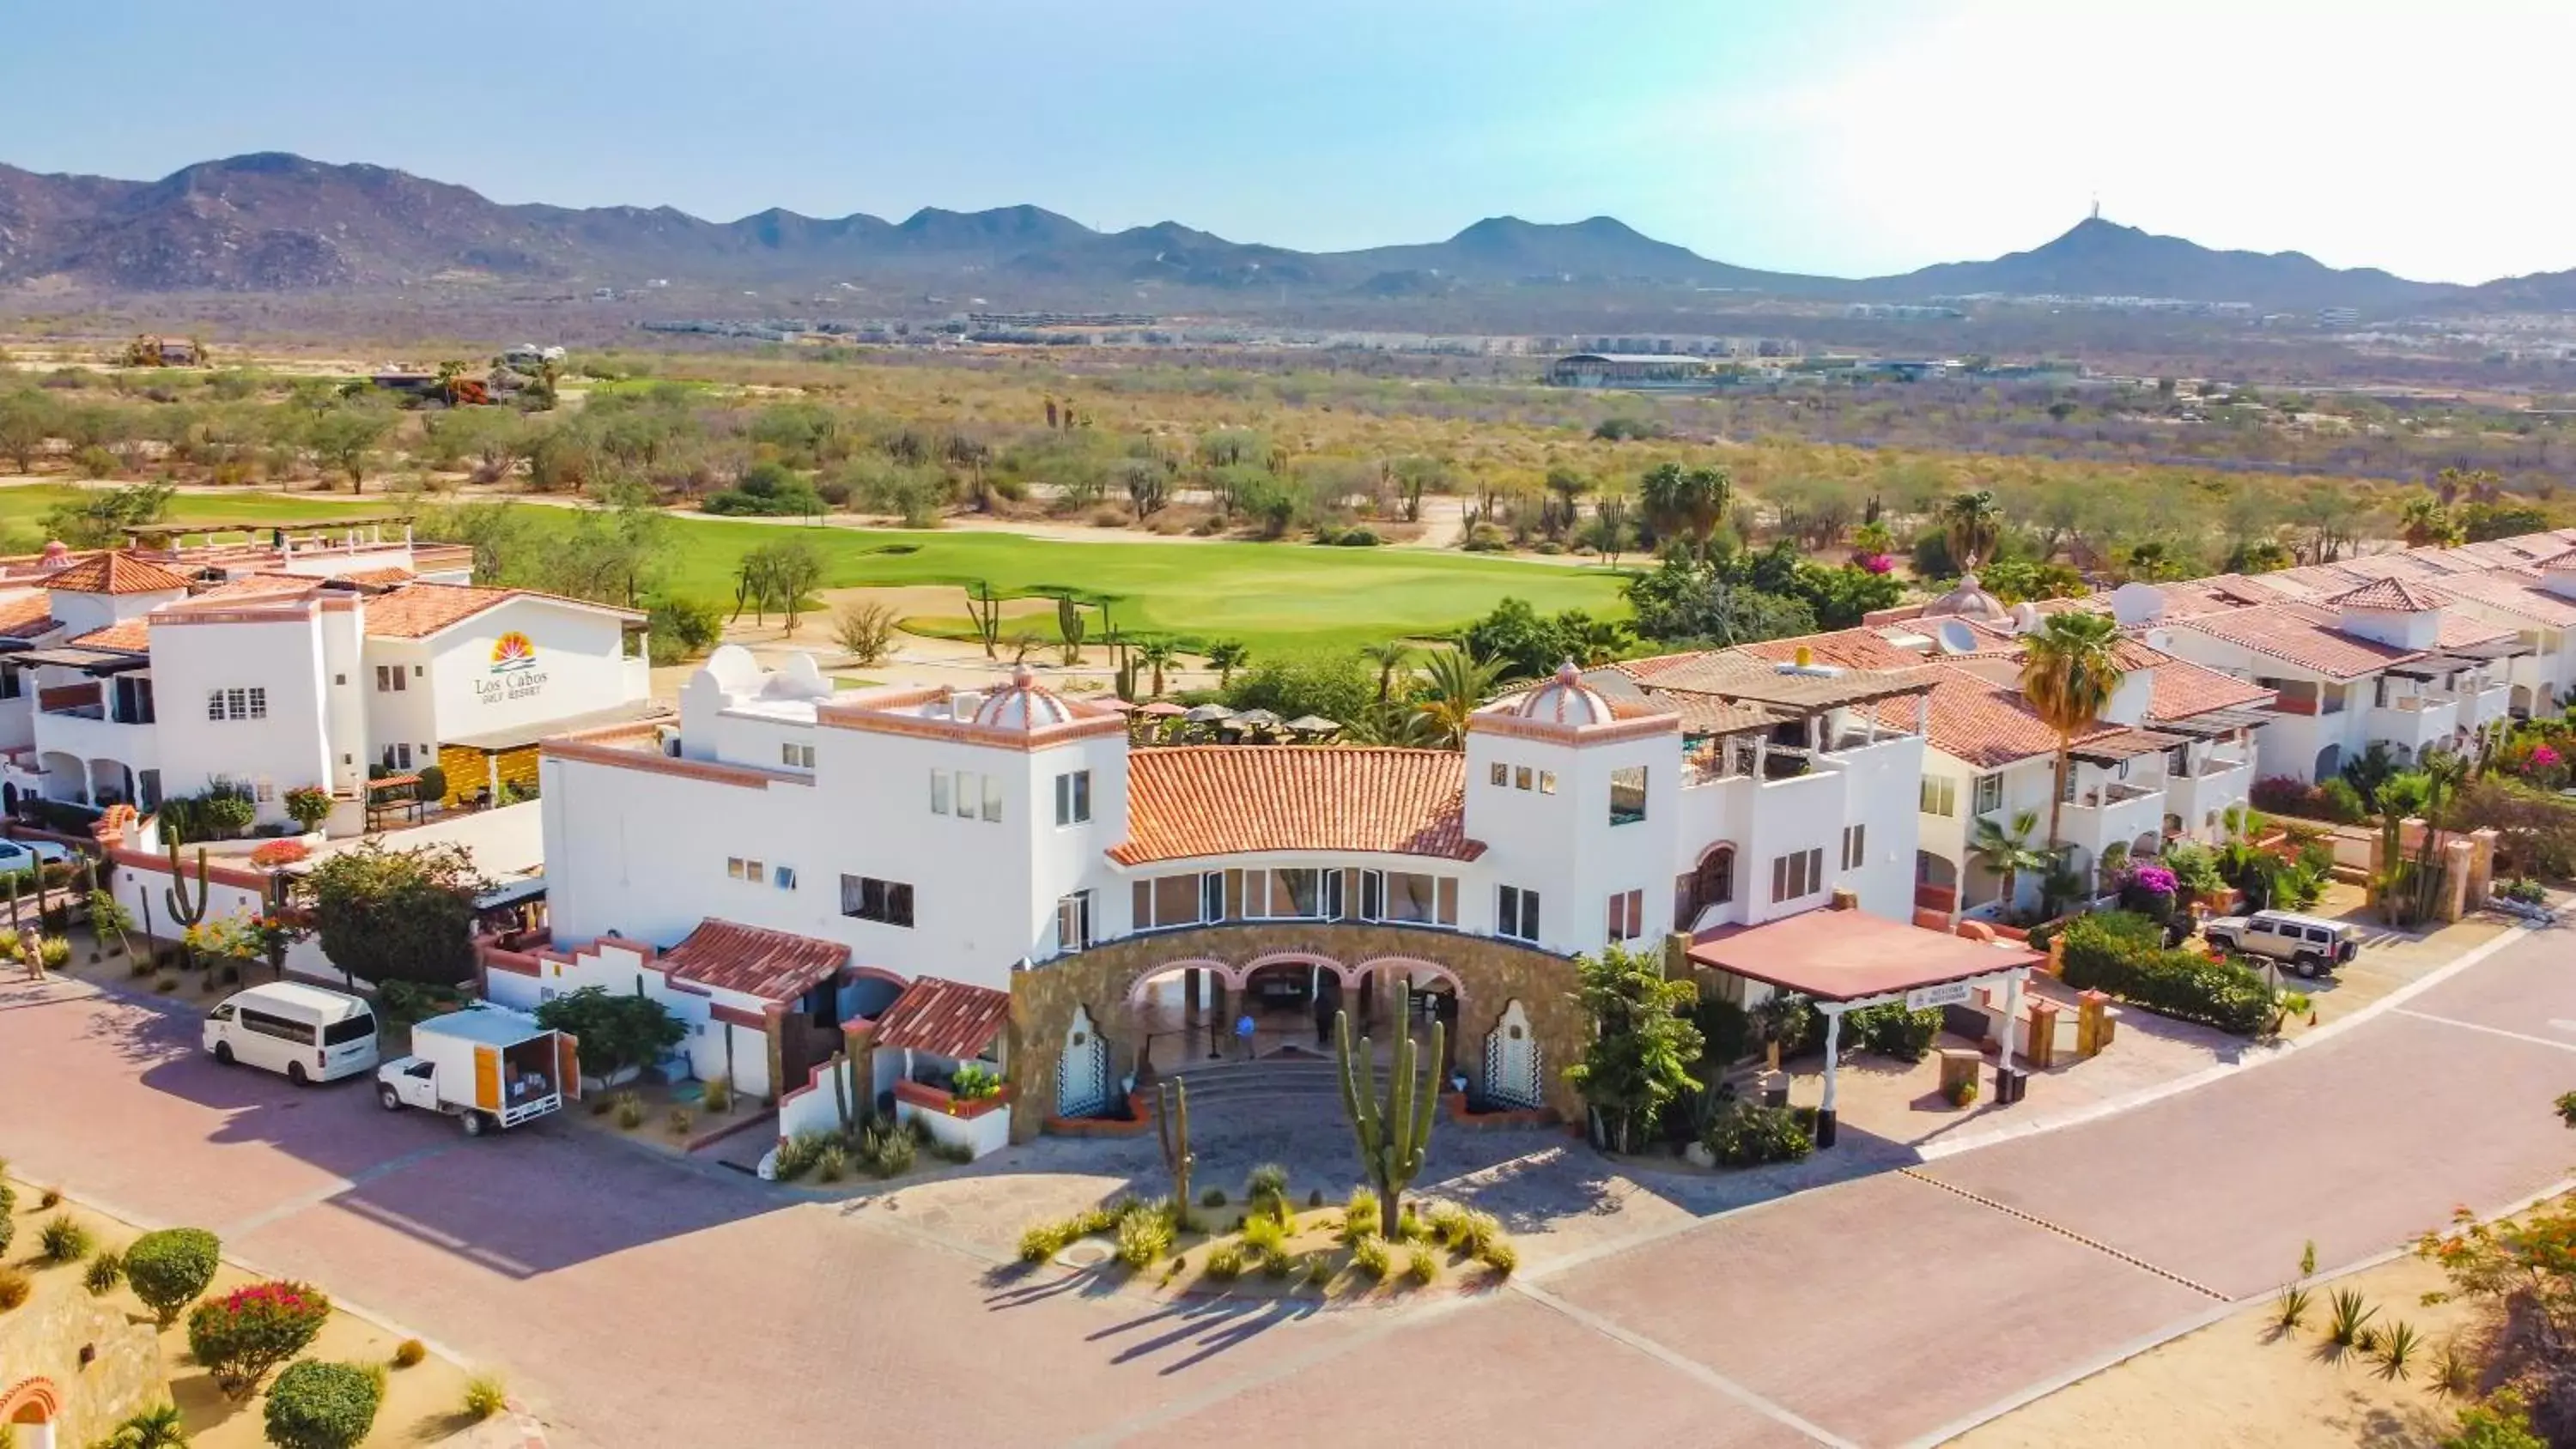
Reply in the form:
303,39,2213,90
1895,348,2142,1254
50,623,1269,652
1110,743,1484,864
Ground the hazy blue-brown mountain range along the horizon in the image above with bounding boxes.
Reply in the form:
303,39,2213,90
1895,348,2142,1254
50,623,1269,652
0,152,2576,314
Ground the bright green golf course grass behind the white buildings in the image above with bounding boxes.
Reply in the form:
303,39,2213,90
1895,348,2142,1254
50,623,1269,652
0,487,1628,654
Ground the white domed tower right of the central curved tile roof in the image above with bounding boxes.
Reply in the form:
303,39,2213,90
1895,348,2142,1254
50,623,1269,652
1463,662,1682,955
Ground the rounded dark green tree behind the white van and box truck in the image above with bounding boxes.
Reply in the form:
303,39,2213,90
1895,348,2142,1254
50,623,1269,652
304,839,492,985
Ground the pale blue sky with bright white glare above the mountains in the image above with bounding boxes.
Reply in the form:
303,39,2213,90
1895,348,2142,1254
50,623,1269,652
0,0,2576,281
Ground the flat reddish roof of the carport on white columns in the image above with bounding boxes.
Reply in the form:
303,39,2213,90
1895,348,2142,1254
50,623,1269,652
1690,908,2043,1001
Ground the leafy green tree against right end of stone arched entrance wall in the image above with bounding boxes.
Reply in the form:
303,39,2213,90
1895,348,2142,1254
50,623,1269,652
1566,944,1705,1153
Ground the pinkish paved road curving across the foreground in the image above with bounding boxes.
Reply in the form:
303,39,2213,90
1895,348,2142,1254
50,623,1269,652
0,931,2576,1446
